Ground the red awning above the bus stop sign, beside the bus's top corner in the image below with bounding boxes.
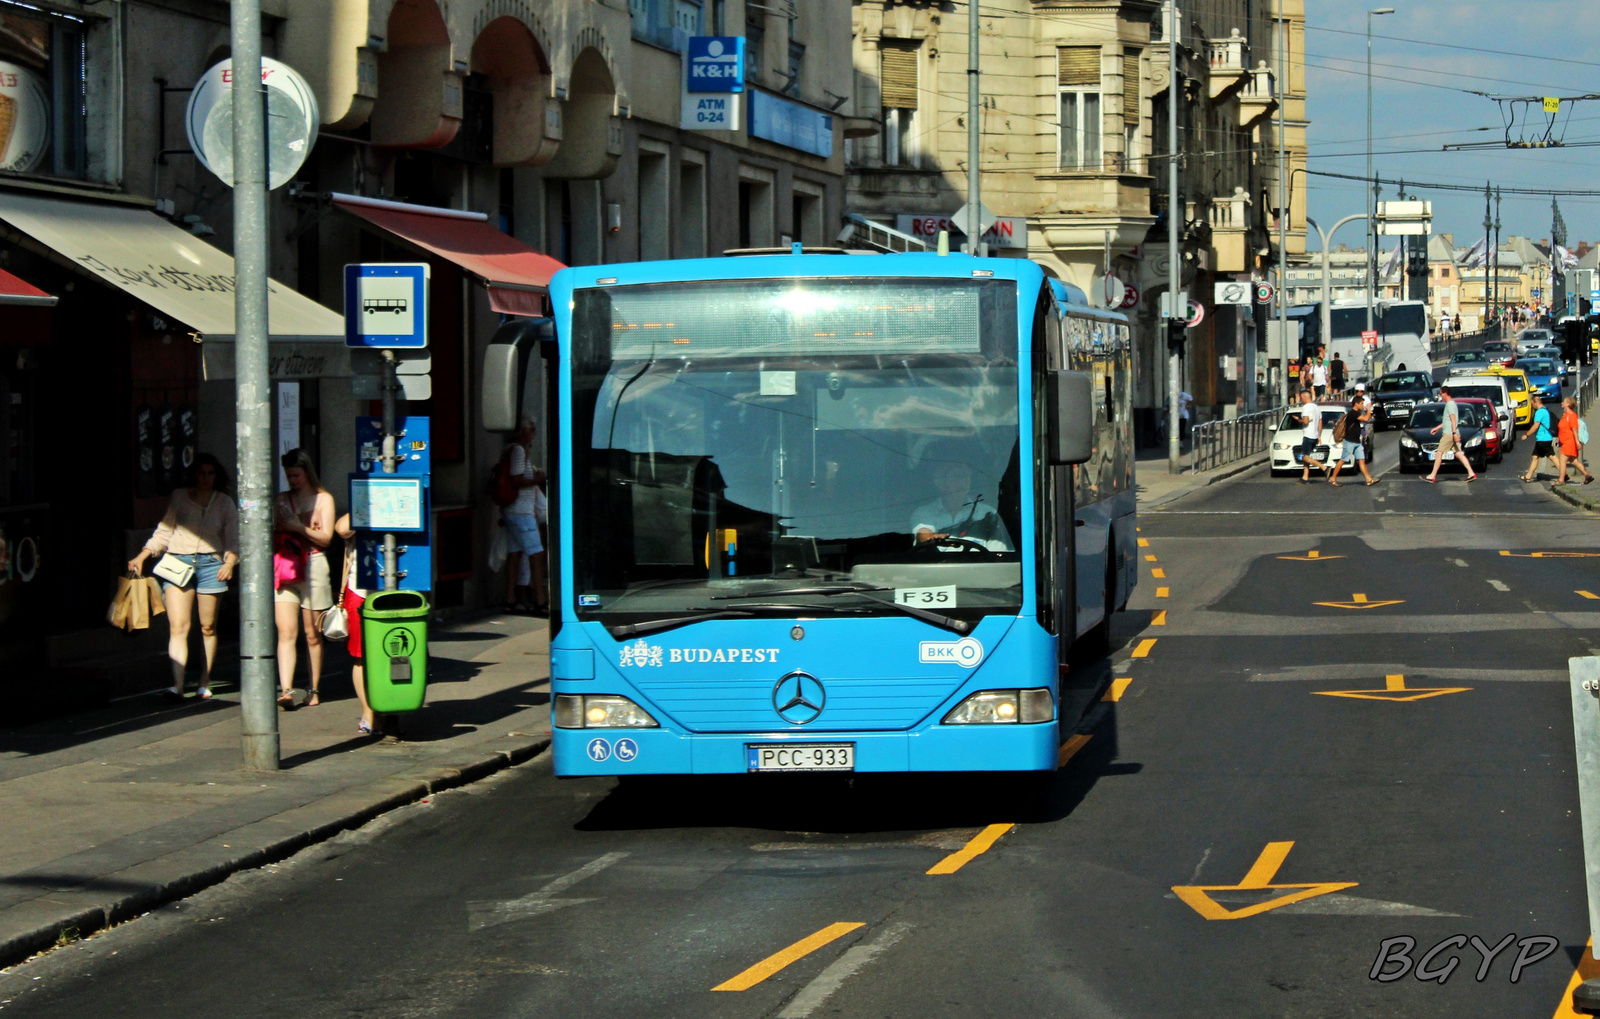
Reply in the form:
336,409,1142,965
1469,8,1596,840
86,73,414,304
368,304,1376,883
333,194,565,315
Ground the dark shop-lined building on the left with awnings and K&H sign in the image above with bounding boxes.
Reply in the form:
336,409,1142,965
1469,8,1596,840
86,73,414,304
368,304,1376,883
0,0,851,684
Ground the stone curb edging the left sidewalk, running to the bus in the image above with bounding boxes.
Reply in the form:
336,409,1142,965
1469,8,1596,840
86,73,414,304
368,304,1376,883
0,736,550,969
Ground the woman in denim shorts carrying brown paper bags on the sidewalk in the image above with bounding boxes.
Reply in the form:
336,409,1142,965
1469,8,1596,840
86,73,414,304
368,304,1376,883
128,453,238,701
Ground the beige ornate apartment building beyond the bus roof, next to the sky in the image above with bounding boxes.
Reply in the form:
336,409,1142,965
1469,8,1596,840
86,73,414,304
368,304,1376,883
846,0,1306,440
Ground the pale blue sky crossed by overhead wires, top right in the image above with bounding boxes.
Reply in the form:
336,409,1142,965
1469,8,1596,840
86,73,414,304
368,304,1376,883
1294,0,1600,250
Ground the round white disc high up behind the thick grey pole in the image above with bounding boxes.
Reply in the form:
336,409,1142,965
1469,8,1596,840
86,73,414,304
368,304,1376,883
184,56,322,190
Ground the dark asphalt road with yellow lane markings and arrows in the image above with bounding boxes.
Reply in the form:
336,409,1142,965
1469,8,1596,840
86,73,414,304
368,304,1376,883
0,444,1600,1019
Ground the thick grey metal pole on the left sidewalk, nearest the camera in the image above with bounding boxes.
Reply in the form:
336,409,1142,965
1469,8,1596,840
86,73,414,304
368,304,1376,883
230,0,278,771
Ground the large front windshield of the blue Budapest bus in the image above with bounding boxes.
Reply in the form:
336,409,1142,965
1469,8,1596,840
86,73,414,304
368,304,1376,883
571,278,1022,624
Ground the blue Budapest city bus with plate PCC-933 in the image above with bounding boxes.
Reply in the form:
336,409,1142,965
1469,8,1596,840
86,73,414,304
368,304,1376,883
483,253,1136,776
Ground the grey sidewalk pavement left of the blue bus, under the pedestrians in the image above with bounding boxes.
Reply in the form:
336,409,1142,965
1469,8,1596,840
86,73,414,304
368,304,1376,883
0,616,550,966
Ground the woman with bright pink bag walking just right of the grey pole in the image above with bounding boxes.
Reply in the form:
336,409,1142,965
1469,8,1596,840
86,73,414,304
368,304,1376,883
274,450,333,710
